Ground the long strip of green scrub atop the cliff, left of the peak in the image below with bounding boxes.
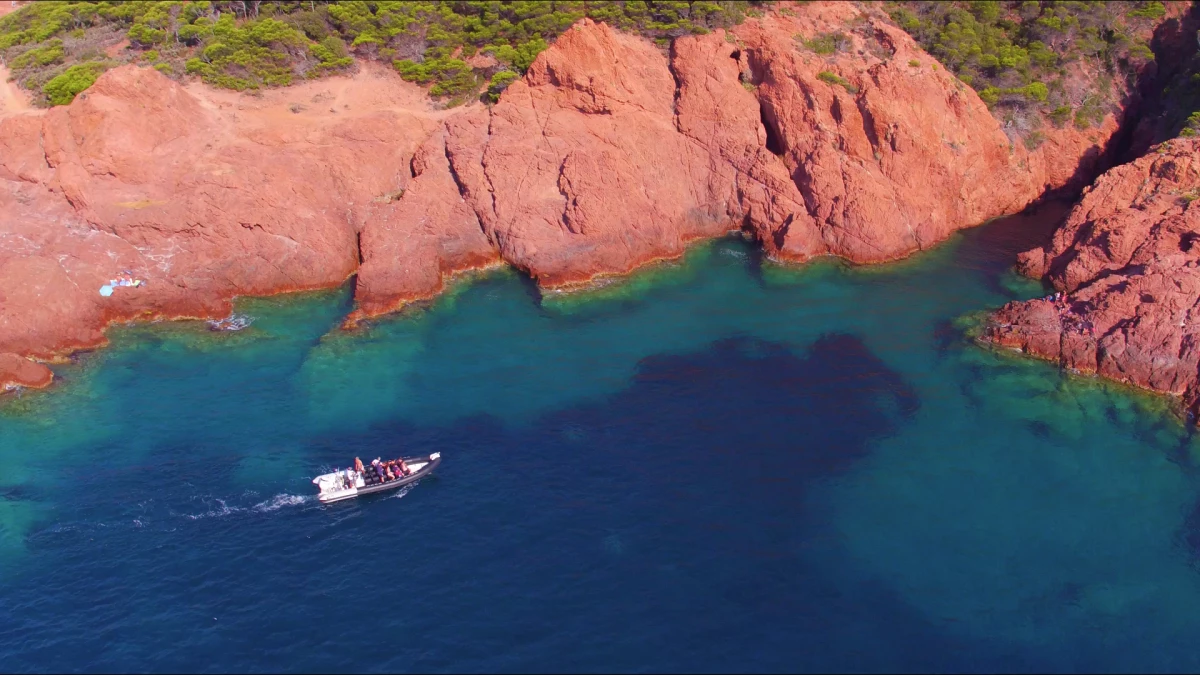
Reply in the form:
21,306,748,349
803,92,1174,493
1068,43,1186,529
0,0,758,104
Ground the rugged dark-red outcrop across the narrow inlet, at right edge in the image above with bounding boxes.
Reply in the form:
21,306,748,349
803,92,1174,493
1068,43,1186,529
986,138,1200,406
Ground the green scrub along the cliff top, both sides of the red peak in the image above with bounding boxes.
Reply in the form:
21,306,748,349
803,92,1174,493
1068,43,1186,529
0,0,1180,137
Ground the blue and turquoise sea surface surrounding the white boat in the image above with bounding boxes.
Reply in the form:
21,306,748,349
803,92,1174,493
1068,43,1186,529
0,205,1200,673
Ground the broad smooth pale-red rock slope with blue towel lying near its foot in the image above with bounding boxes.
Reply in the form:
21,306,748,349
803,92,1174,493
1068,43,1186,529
0,66,442,359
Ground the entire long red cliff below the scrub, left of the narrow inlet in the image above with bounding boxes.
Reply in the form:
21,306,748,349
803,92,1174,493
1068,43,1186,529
0,4,1116,374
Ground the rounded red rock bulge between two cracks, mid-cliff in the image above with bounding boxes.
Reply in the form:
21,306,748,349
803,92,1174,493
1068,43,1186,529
449,20,738,286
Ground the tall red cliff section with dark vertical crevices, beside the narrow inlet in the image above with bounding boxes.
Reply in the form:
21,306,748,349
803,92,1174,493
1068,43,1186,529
724,4,1116,262
